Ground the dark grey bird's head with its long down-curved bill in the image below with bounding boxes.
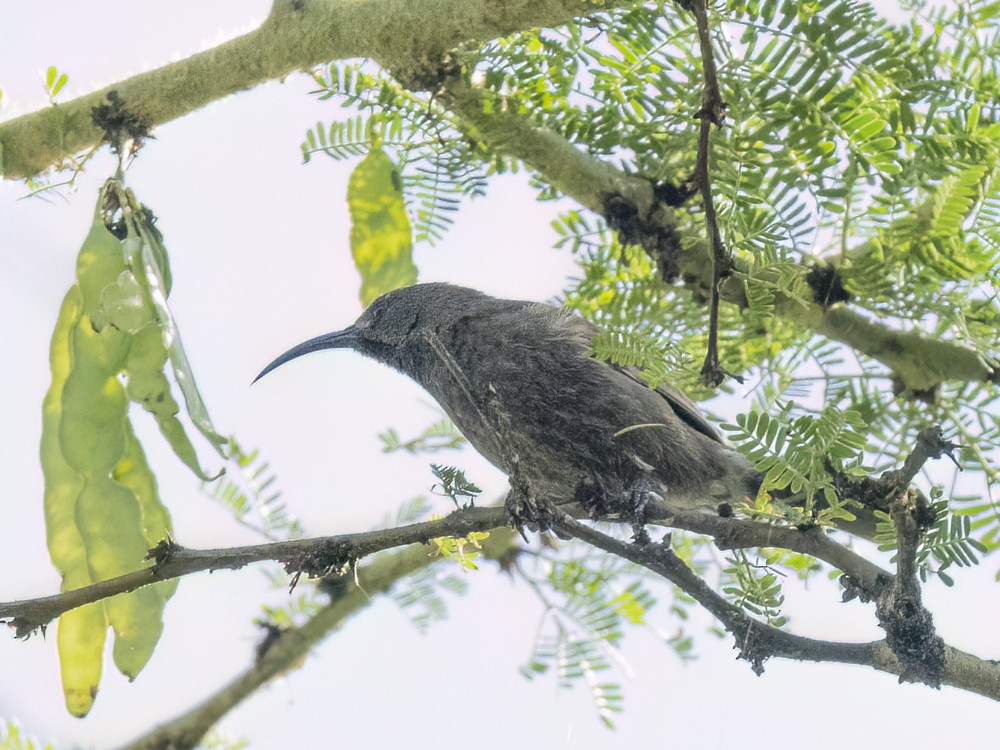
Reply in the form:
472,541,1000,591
254,283,490,382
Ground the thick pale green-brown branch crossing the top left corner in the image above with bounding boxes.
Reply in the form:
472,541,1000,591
0,0,638,179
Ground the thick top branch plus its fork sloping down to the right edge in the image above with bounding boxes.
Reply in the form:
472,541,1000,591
0,0,997,391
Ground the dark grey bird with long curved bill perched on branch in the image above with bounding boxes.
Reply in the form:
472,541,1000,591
254,282,762,534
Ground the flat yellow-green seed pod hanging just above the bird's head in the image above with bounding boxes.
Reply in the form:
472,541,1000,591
347,148,417,306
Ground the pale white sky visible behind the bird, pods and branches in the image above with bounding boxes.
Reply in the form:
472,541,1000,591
0,0,1000,750
